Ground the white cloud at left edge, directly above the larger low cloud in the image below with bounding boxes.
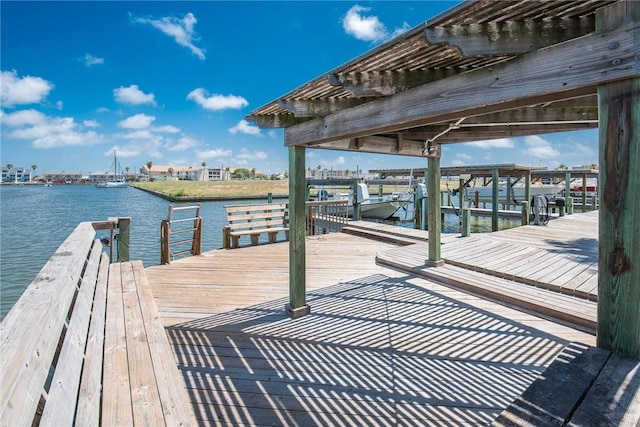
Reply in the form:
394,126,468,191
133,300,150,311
0,70,54,107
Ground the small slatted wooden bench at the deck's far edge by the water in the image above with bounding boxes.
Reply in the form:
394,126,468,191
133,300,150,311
222,203,289,249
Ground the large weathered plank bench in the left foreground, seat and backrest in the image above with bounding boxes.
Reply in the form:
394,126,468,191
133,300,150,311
0,222,195,426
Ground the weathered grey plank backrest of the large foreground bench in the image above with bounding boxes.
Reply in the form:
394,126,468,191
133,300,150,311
0,222,109,425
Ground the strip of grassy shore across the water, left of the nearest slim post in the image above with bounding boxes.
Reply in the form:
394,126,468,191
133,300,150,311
133,180,289,199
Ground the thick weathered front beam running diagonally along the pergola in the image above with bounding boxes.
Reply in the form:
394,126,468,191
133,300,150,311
285,24,640,146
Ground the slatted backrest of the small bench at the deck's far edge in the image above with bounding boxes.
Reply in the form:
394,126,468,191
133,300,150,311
224,203,289,232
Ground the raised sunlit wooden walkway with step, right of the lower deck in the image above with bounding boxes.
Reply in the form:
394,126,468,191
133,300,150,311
377,212,598,333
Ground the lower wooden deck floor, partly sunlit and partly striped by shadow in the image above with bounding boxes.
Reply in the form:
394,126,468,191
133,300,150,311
145,226,595,426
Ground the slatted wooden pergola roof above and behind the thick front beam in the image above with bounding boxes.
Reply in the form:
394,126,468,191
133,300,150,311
247,0,615,156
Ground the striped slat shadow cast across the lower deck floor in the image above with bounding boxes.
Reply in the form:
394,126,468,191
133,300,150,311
168,274,591,426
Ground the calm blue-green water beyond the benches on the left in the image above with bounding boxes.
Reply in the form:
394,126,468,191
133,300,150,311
0,185,266,317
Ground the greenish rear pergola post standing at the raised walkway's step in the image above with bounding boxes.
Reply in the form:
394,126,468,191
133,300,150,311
426,149,444,267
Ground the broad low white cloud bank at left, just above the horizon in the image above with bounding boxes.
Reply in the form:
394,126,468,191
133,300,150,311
2,110,103,148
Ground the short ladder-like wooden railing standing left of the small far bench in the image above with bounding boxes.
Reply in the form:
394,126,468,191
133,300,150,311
160,205,202,264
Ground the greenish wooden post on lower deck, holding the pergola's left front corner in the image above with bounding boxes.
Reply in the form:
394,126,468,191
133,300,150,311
285,147,311,318
